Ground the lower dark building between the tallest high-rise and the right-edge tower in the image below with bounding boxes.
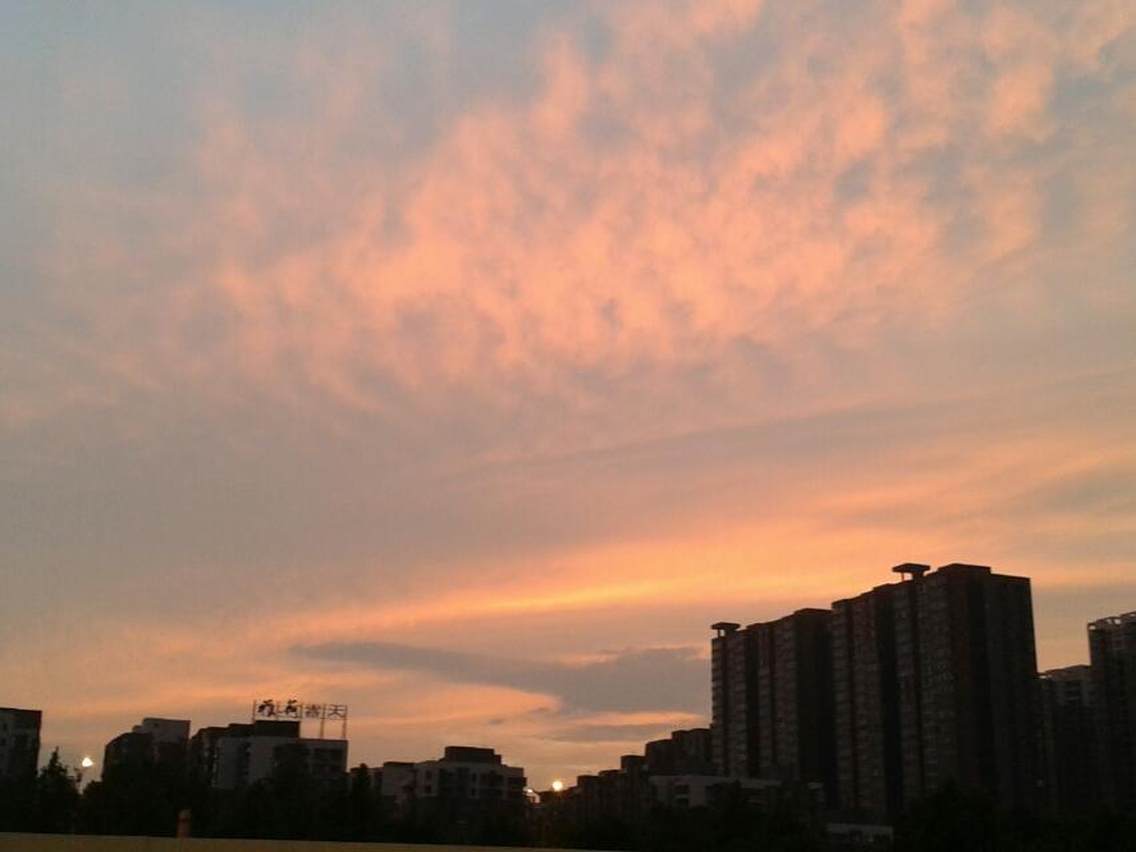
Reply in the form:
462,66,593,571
1038,666,1101,815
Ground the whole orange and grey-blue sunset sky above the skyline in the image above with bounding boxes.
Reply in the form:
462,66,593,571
0,0,1136,786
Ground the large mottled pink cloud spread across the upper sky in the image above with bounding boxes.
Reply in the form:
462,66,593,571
8,2,1134,433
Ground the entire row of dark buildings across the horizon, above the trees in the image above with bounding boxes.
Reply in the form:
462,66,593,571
0,562,1136,838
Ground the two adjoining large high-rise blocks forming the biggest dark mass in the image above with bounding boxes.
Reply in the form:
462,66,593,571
711,563,1038,820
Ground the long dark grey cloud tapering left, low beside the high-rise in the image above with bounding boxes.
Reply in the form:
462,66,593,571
293,642,709,717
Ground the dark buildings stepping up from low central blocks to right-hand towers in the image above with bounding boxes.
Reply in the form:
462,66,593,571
542,562,1136,825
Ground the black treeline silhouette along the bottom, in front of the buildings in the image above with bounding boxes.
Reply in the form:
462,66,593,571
0,753,1136,852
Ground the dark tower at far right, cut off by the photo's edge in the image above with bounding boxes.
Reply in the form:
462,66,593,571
1088,612,1136,810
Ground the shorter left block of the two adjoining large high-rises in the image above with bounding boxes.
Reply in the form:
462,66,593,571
710,609,835,795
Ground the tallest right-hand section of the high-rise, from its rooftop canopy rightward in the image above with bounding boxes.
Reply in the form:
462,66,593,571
893,563,1041,808
